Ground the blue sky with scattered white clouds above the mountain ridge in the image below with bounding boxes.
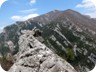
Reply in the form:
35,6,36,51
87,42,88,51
0,0,96,30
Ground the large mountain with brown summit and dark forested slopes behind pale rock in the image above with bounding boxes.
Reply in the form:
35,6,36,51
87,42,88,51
0,9,96,72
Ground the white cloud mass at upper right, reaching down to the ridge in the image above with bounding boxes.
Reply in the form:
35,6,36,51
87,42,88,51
76,0,96,18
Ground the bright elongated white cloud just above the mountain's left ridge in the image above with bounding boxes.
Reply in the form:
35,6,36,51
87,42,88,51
11,14,39,21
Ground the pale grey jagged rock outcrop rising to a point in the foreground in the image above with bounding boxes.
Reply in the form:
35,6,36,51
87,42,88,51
8,30,76,72
